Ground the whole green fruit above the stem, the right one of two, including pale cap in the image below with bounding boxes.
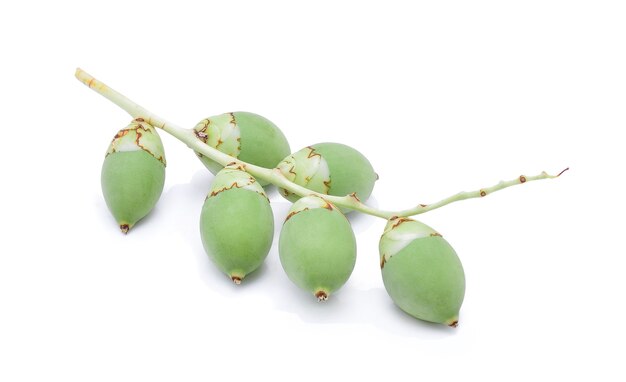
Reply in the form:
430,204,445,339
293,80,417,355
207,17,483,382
277,143,378,210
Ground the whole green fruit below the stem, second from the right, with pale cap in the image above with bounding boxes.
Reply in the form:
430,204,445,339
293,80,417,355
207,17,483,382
278,196,356,301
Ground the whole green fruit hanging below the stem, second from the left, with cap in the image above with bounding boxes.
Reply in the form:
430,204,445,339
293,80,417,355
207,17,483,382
200,165,274,284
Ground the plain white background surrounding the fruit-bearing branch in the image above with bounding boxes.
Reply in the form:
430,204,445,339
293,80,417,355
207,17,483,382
0,0,626,381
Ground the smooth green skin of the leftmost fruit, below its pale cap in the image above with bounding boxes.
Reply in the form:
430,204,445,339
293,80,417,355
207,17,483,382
100,150,165,228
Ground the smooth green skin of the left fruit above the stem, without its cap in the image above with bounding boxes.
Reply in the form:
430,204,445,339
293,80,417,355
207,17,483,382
200,111,291,186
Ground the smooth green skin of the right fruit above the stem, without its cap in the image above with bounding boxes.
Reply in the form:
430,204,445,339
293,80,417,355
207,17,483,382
286,142,378,206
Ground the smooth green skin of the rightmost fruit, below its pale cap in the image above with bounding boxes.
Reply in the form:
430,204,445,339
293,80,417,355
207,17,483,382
382,236,465,325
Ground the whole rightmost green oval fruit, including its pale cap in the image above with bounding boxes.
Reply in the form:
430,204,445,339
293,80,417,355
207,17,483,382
379,217,465,326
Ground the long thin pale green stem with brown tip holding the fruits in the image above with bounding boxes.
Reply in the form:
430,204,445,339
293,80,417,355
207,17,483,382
75,68,567,219
